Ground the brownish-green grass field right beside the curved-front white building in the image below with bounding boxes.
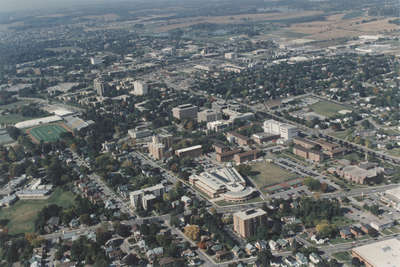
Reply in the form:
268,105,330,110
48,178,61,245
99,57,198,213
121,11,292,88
251,162,298,192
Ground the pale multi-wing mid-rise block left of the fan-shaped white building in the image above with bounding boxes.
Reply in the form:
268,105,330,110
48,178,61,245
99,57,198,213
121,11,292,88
129,184,165,210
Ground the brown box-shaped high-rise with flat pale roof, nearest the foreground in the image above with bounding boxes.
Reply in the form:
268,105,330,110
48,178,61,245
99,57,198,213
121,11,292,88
233,209,267,238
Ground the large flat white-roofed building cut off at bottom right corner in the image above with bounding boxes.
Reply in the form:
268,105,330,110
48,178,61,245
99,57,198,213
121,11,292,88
352,238,400,267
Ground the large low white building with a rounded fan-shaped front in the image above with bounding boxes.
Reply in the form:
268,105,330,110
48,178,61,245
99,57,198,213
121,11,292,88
189,168,255,202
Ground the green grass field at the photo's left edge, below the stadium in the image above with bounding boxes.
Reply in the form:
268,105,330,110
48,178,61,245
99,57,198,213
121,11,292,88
0,188,74,235
